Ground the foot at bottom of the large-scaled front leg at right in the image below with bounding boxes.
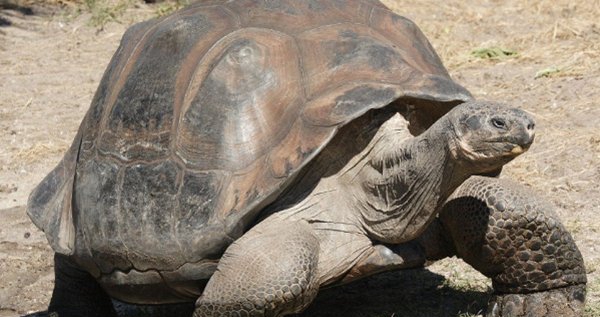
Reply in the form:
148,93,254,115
486,284,585,317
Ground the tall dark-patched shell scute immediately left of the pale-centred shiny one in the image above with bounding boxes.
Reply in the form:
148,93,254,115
98,7,230,161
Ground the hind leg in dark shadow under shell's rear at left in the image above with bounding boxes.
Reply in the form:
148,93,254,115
48,253,117,317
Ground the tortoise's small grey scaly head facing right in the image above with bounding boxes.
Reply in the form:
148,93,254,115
447,101,535,172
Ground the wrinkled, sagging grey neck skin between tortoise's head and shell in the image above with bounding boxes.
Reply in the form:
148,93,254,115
355,120,468,243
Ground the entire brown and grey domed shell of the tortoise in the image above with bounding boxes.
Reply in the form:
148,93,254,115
28,0,471,274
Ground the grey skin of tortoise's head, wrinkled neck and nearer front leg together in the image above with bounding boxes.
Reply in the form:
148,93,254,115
195,102,534,316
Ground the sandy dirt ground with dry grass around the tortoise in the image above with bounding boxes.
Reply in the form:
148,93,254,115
0,0,600,317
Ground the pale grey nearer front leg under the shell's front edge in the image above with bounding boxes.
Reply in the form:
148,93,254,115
194,219,319,317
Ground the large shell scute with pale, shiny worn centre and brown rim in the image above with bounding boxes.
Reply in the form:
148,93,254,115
175,29,304,171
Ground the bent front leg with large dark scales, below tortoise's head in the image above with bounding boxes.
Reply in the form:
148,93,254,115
440,177,586,317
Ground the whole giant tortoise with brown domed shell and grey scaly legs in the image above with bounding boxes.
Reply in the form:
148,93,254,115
28,0,586,316
